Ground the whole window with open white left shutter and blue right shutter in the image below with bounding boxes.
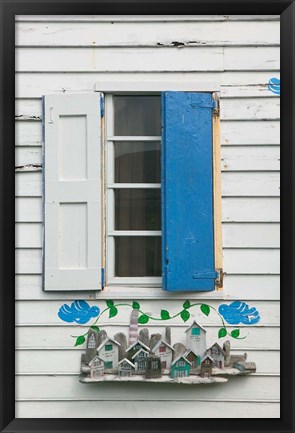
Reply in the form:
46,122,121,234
43,86,222,292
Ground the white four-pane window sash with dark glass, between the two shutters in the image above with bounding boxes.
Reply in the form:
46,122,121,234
105,95,162,286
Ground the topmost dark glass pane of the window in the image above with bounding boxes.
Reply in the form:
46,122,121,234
113,96,161,135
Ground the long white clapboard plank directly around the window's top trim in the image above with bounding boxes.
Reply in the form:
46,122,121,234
16,70,280,98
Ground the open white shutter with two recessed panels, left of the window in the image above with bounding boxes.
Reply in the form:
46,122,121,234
43,93,102,290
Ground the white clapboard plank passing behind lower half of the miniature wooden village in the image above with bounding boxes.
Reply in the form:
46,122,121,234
15,350,280,375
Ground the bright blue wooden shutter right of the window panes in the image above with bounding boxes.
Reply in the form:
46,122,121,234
162,92,217,291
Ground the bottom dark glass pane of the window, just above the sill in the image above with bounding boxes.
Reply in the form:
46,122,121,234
115,236,161,277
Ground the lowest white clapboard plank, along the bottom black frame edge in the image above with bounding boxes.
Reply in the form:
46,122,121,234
16,399,280,416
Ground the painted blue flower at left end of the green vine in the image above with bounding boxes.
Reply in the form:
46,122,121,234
58,301,100,325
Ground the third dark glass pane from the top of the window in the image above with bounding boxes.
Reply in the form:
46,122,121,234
114,188,161,230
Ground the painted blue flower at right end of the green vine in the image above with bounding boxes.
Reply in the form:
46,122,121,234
218,301,260,325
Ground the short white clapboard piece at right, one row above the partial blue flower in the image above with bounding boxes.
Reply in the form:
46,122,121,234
224,47,280,71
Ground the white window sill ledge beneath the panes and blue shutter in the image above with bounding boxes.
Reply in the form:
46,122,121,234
95,286,227,300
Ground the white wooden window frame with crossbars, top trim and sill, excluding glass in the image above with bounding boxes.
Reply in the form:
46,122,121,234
94,81,222,298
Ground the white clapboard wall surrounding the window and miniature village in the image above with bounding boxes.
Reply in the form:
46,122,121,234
15,15,280,418
